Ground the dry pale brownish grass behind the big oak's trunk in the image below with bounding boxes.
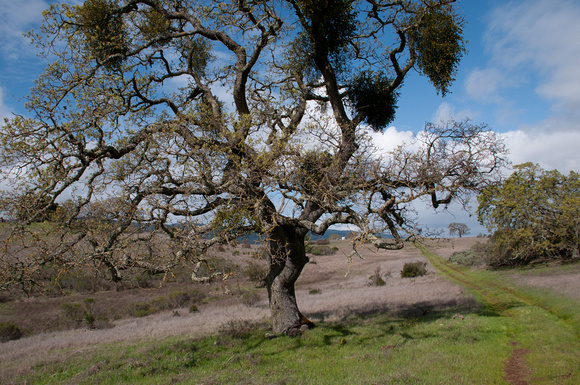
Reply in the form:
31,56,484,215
0,238,579,383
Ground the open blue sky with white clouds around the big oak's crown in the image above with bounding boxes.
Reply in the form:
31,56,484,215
0,0,580,235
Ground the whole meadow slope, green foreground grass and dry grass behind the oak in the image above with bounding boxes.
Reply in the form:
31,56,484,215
0,238,580,384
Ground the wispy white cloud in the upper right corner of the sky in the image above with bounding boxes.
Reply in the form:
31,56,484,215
482,0,580,114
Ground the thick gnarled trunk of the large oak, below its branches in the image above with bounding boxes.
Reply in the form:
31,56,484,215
266,226,314,336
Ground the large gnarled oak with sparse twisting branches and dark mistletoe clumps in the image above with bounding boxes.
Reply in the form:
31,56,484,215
0,0,503,332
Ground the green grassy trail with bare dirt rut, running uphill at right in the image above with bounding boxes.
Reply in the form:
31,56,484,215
417,245,580,384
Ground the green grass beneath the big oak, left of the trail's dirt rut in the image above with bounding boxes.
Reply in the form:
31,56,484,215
12,314,510,384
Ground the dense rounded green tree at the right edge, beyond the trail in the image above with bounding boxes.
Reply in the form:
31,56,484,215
478,163,580,265
